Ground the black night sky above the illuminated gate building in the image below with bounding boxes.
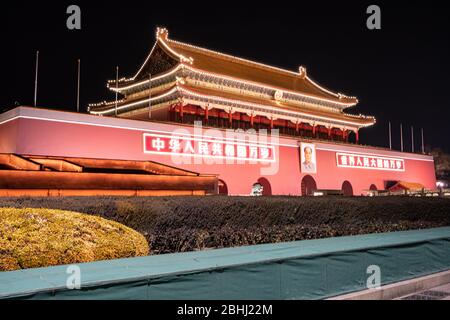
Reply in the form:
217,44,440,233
0,0,450,152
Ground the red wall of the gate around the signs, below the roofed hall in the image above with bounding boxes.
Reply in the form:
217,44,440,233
0,107,436,195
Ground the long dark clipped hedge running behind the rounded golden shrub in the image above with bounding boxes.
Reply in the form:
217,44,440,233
0,196,450,253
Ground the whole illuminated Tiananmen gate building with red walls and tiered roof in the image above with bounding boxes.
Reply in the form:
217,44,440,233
0,29,436,195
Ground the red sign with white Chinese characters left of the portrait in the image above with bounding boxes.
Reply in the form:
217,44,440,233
144,134,275,162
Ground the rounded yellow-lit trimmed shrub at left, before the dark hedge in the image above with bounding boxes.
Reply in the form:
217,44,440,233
0,208,149,271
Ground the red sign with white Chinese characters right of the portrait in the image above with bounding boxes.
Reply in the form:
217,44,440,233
336,153,405,171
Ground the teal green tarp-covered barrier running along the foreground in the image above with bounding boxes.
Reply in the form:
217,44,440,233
0,227,450,300
